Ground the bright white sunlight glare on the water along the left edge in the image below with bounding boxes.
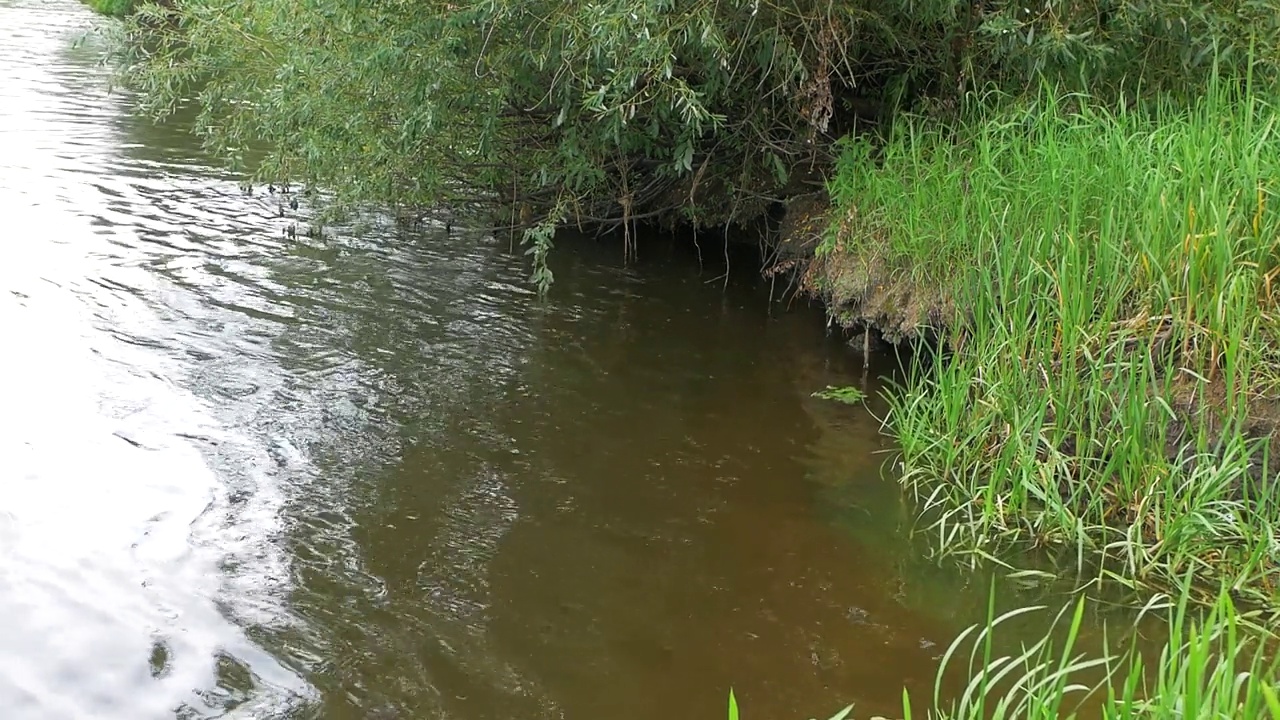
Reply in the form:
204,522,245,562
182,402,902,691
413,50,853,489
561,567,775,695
0,1,310,720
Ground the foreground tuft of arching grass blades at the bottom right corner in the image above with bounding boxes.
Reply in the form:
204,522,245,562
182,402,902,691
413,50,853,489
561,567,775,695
902,584,1280,720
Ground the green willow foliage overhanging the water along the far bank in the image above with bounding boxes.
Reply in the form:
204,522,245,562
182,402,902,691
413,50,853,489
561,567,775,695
117,0,1280,240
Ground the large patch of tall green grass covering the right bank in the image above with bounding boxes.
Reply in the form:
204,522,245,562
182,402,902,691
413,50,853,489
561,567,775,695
819,79,1280,603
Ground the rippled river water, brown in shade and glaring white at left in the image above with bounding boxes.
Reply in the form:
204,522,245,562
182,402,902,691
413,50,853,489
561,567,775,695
0,0,1054,720
